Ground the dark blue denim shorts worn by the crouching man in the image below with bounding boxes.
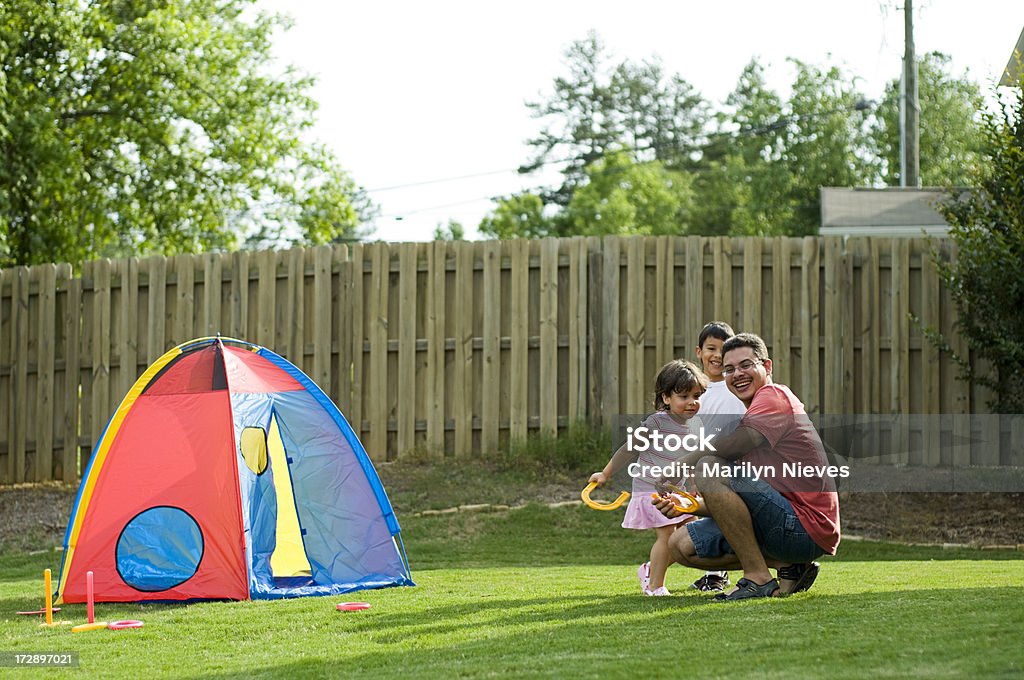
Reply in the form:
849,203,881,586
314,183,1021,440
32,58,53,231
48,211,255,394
685,477,824,564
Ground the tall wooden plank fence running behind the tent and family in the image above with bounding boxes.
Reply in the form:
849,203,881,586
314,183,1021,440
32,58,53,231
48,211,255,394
0,237,998,482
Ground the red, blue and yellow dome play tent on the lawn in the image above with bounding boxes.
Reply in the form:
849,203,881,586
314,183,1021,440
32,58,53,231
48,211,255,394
57,337,413,602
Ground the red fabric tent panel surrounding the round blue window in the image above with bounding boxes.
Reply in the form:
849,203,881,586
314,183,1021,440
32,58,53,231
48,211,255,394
63,391,249,602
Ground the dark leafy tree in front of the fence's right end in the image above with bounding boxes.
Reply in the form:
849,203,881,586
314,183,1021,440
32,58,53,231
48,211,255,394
928,87,1024,414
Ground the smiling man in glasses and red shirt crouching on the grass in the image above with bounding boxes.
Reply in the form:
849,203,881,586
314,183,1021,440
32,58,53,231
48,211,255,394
652,333,840,601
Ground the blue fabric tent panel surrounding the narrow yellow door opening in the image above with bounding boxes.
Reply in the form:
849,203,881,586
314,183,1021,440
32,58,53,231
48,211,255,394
231,349,415,598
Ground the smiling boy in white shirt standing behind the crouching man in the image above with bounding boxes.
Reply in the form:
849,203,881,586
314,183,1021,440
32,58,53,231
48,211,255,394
690,322,746,593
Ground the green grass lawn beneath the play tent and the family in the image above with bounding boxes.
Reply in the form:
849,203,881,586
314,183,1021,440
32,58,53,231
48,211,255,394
0,506,1024,680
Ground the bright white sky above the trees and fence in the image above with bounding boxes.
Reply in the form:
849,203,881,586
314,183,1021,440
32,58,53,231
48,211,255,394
257,0,1024,242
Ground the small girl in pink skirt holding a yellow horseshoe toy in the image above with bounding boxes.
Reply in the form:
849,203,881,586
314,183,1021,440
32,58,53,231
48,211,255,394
590,359,708,596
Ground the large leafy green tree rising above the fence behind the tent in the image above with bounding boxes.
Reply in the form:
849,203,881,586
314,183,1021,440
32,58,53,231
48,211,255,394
0,0,372,265
